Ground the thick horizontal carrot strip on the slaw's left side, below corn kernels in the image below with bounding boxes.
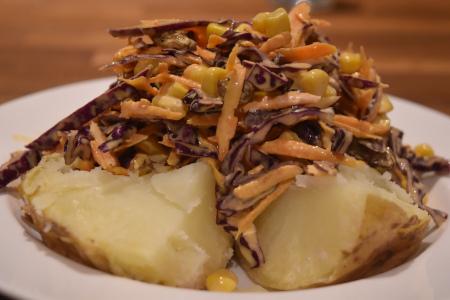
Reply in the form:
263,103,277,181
120,98,185,120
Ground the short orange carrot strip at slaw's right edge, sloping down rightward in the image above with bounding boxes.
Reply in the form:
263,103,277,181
333,114,390,139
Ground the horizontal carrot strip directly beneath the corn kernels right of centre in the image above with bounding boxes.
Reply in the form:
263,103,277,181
242,92,320,112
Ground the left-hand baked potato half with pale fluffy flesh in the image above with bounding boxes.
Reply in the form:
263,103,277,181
22,154,232,288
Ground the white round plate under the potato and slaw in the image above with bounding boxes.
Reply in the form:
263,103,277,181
0,78,450,300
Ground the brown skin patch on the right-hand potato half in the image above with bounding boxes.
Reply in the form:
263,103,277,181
327,195,430,285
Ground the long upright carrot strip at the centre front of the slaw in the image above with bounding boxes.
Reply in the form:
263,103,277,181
216,64,246,161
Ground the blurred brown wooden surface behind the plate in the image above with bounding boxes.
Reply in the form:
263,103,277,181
0,0,450,115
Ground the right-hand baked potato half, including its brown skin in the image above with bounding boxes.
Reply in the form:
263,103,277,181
241,166,430,290
